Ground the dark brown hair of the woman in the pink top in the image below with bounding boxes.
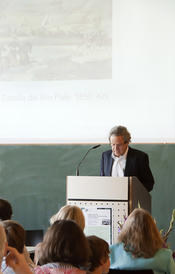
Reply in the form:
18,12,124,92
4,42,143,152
39,220,90,267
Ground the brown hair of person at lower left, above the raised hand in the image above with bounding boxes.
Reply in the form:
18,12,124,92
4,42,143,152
1,220,25,253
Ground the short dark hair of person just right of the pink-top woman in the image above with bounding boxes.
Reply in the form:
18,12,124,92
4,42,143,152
87,235,110,271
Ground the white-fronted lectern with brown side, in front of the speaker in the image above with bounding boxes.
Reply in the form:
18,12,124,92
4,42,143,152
66,176,151,244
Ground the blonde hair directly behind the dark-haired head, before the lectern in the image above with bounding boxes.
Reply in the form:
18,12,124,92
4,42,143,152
50,205,85,230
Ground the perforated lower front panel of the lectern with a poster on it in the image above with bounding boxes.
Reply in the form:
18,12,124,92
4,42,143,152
68,201,128,245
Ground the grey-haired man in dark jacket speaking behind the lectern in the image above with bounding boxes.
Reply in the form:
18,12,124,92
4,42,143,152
100,126,154,191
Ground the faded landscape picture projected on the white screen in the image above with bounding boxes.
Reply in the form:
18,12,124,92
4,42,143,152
0,0,112,81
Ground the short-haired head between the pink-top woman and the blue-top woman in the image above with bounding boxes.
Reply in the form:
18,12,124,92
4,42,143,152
87,236,110,273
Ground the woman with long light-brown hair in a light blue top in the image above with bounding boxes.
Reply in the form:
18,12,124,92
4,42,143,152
110,208,175,274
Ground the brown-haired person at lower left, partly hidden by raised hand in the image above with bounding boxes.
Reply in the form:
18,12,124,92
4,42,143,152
1,220,34,274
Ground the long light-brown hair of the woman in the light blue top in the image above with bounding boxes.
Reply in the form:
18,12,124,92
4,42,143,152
118,208,164,258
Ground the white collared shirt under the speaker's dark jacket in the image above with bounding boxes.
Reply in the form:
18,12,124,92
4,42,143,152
112,148,128,177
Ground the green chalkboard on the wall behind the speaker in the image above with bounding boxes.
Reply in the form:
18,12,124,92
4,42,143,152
0,144,175,248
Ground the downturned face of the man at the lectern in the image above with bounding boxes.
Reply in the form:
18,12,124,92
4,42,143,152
110,135,128,157
